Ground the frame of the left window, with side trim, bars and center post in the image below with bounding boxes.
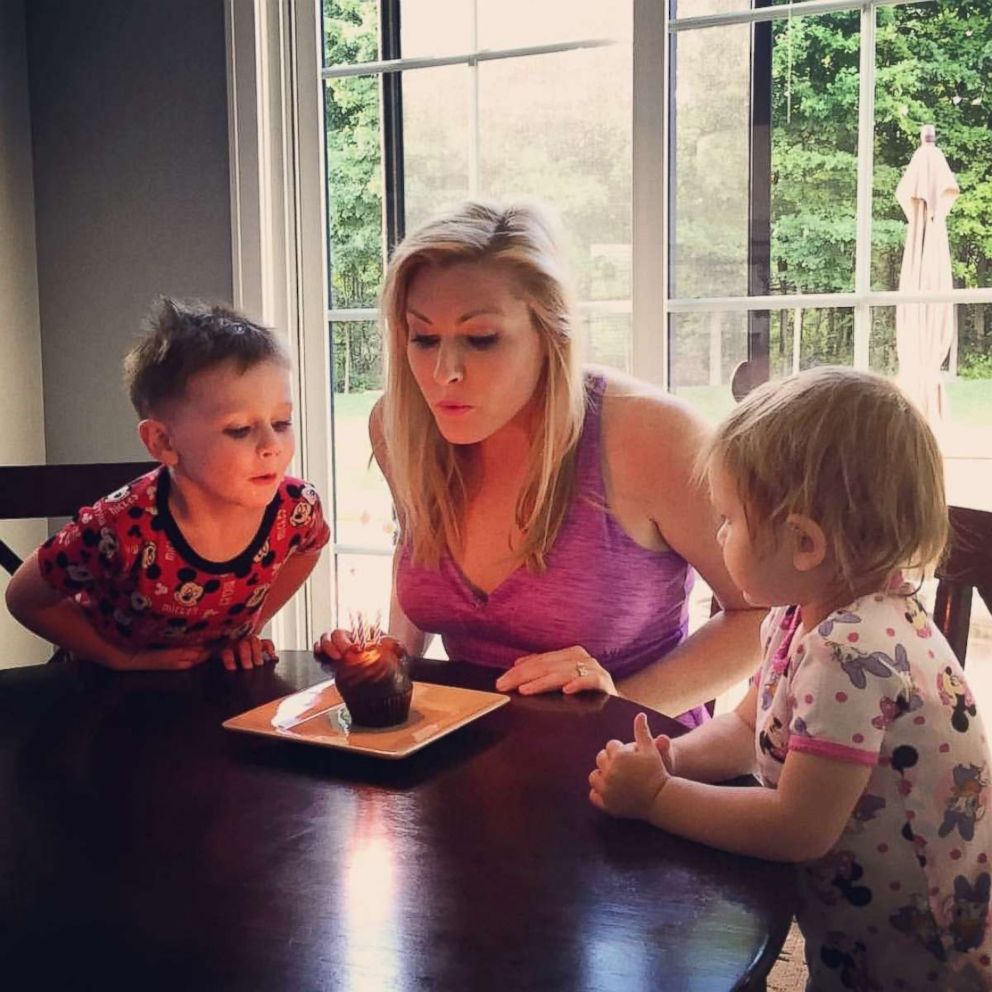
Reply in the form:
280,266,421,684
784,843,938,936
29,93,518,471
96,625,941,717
225,0,667,646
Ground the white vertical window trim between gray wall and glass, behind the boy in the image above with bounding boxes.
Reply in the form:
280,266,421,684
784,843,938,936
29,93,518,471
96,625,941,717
224,0,335,648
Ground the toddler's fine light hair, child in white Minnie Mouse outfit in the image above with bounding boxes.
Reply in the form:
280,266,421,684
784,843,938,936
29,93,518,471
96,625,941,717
704,366,948,589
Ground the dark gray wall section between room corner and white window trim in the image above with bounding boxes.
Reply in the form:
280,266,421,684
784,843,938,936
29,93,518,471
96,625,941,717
25,0,232,462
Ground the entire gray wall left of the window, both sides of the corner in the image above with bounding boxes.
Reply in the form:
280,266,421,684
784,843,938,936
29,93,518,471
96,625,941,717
0,0,232,667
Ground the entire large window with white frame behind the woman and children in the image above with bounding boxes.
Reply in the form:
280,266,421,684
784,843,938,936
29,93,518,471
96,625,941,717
229,0,992,644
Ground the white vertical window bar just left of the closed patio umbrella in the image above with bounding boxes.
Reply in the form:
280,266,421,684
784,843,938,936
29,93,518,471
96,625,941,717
854,4,875,369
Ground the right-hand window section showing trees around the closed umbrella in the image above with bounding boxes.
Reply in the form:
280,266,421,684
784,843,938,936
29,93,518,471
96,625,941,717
668,0,992,410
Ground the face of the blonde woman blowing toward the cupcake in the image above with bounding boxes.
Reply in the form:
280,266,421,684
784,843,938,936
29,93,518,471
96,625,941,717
406,262,545,444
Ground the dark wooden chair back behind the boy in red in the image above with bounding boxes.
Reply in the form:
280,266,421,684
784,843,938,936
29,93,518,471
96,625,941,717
0,462,157,575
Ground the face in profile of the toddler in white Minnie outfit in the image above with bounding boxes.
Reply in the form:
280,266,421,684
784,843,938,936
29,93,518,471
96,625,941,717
709,461,805,606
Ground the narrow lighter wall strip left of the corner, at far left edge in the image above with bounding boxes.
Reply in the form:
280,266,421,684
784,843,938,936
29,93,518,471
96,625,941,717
0,0,50,666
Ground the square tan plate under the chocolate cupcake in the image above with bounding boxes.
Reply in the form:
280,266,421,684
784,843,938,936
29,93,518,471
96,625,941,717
223,679,510,758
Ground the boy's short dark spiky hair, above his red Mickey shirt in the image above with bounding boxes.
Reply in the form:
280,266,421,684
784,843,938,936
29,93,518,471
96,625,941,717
124,297,289,417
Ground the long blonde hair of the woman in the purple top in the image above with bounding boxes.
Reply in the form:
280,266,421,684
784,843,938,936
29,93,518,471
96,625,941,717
379,202,585,570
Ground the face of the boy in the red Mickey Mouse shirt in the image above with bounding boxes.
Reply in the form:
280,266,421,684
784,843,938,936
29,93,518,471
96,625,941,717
158,362,296,509
